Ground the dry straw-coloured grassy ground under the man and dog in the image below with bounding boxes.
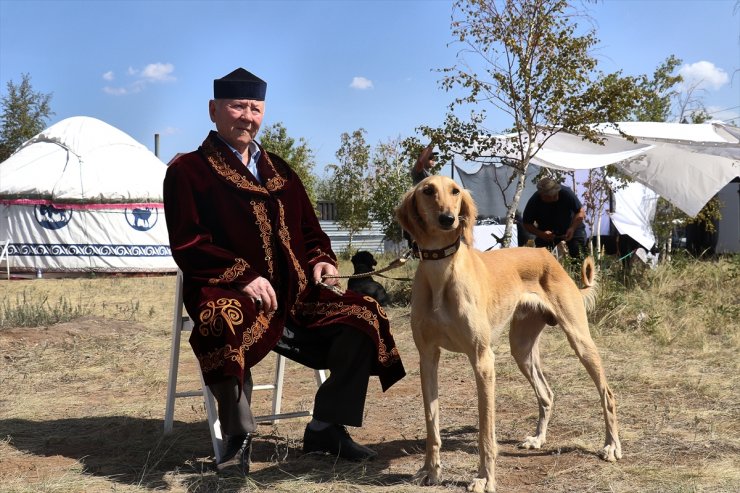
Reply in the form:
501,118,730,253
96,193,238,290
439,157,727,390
0,278,740,493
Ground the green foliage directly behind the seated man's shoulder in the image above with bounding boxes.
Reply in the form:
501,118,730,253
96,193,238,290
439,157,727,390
259,122,317,207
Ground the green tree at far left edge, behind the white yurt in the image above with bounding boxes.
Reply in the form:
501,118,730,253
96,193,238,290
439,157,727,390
0,74,54,162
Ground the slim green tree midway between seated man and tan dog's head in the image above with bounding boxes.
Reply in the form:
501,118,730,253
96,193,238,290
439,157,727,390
327,128,373,252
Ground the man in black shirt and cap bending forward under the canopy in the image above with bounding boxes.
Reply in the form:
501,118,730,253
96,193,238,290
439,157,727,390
522,177,586,257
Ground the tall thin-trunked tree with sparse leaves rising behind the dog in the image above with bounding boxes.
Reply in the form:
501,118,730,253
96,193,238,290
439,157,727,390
421,0,642,245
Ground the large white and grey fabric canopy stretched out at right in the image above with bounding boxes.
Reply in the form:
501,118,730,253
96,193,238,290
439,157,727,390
466,122,740,216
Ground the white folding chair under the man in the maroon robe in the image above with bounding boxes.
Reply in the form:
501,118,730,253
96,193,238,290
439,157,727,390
164,269,326,463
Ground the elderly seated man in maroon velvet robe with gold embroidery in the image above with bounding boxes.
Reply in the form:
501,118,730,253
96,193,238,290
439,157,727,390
164,68,405,474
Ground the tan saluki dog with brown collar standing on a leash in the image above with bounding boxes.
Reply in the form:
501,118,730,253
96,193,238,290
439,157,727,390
396,176,622,492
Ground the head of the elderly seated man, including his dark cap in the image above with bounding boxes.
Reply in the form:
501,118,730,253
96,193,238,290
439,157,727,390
208,68,267,152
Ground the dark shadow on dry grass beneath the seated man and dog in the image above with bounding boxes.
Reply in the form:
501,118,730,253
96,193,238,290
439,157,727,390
0,416,600,493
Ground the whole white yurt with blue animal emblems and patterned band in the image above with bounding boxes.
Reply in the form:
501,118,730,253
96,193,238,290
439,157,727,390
0,116,176,272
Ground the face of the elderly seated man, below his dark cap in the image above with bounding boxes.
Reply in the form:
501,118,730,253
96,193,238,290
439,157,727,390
208,99,265,152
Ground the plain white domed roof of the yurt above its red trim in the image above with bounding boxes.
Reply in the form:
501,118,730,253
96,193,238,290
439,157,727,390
0,116,166,205
